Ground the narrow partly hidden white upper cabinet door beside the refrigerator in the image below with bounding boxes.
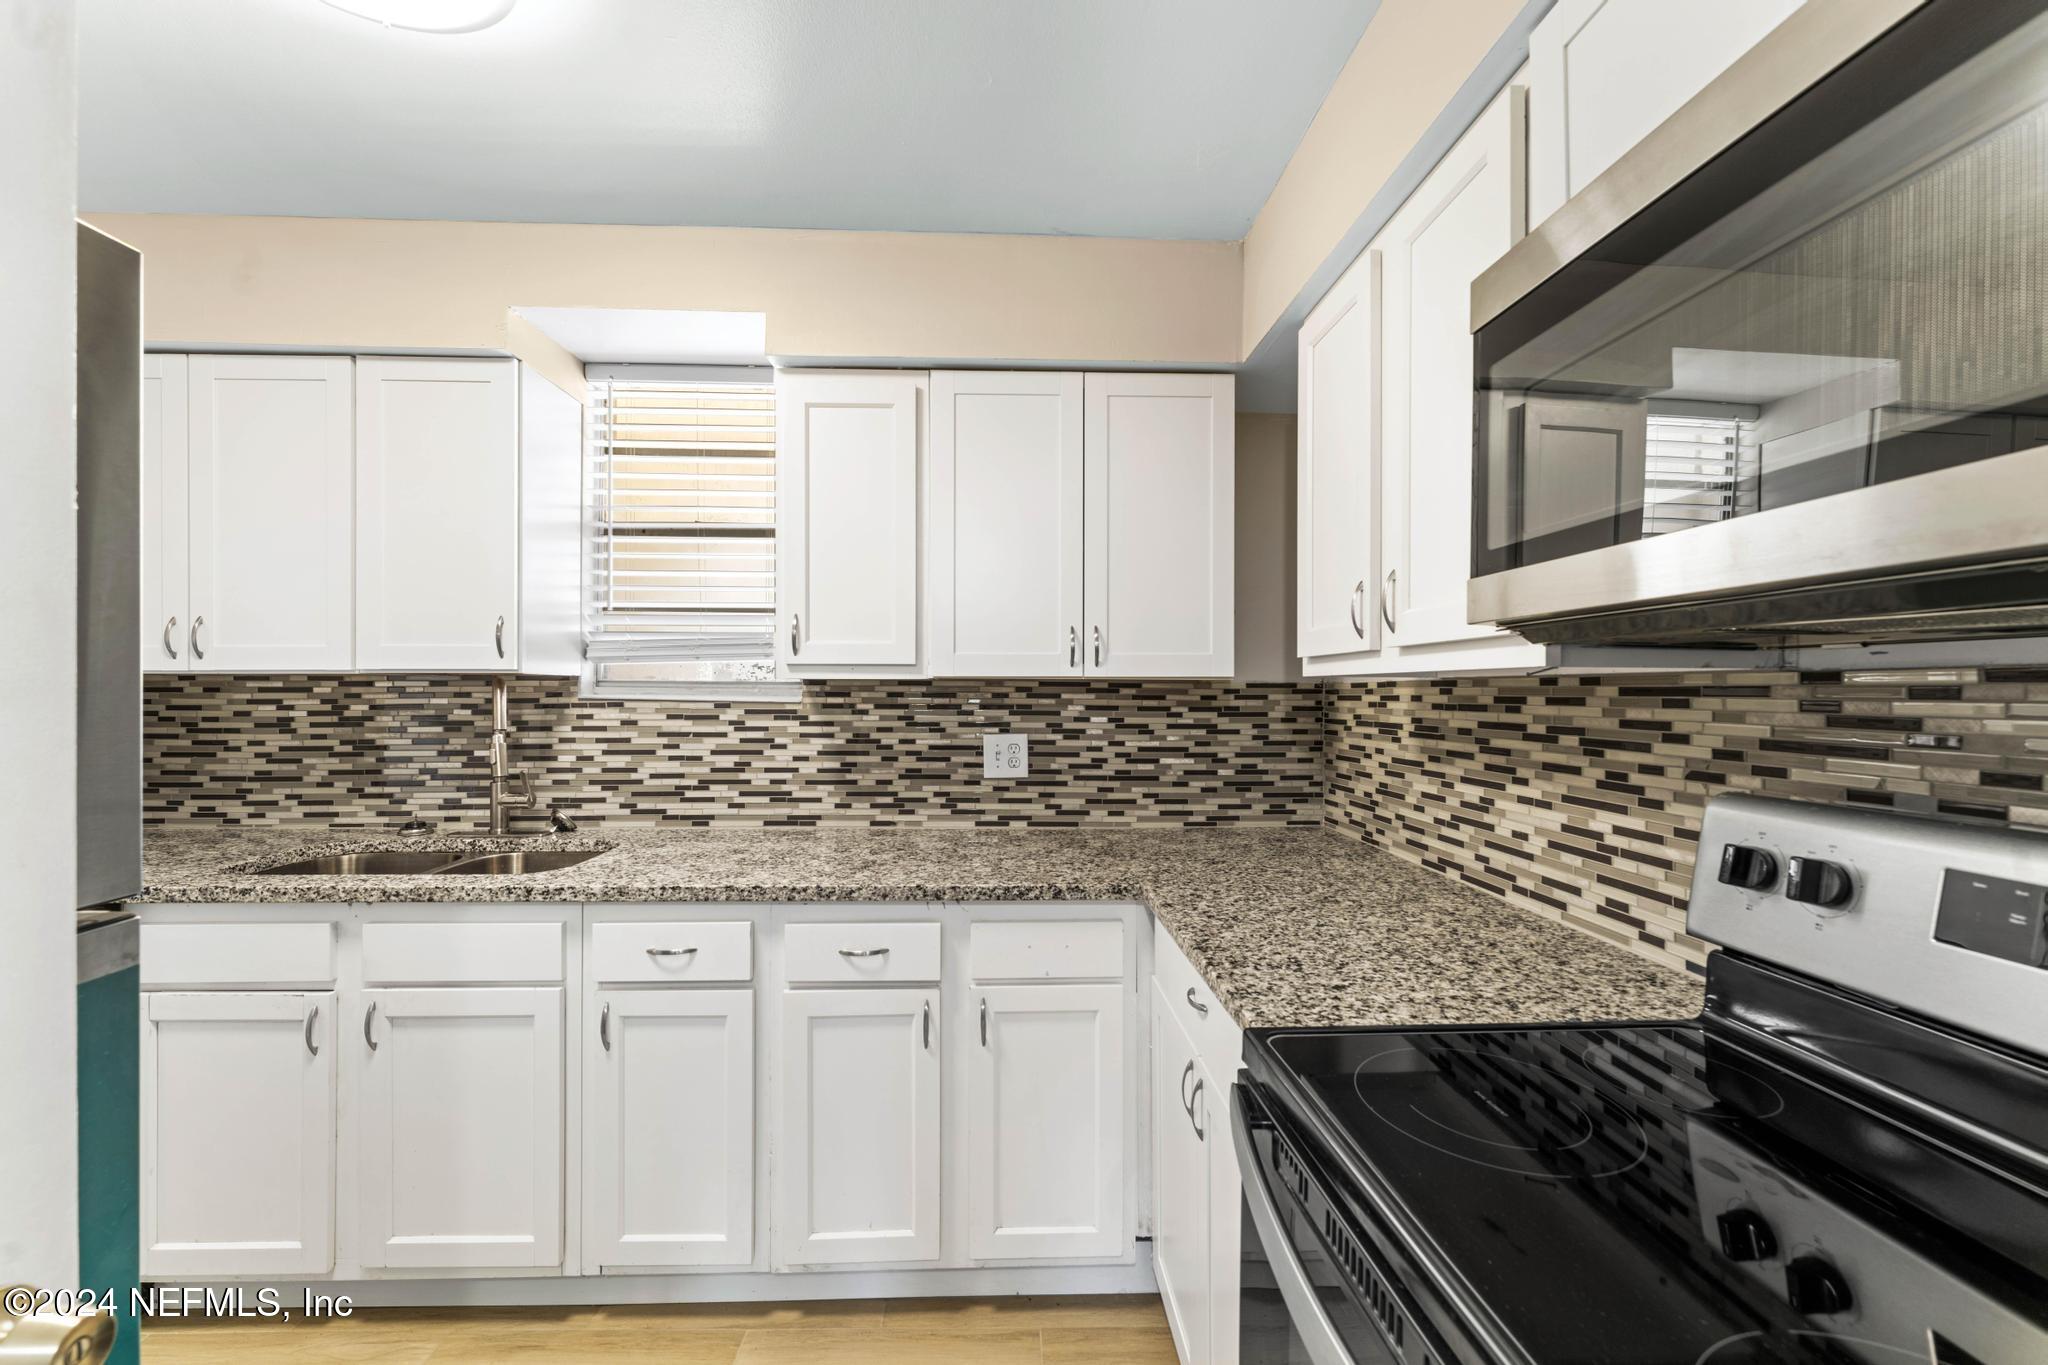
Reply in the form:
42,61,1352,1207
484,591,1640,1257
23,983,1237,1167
141,356,193,673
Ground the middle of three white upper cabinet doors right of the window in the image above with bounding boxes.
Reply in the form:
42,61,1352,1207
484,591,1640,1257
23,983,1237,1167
928,370,1083,677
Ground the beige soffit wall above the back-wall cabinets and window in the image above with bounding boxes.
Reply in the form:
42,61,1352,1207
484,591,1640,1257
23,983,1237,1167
90,213,1241,394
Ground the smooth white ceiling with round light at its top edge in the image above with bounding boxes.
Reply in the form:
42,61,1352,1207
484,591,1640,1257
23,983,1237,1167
80,0,1378,241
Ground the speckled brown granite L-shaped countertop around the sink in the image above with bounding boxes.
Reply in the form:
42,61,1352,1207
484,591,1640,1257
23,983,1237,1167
135,825,1702,1027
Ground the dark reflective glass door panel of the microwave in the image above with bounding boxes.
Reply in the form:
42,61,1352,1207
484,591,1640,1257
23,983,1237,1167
1473,4,2048,577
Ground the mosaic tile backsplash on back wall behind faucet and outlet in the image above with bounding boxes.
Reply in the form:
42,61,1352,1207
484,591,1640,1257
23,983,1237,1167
143,675,1323,827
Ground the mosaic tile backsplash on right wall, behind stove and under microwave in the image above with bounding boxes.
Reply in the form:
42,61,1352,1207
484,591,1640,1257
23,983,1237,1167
1325,667,2048,970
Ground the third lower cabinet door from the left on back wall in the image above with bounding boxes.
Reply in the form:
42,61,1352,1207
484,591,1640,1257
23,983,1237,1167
584,990,754,1271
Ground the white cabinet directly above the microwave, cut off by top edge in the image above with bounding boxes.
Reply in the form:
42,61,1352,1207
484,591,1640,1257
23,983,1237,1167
1528,0,1802,223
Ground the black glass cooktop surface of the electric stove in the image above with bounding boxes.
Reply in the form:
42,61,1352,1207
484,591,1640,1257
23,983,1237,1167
1249,1025,2048,1365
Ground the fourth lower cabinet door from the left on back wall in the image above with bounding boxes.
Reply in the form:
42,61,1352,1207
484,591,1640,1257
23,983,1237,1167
774,988,940,1267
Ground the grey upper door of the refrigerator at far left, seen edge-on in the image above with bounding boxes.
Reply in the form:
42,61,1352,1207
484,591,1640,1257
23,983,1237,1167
78,223,141,909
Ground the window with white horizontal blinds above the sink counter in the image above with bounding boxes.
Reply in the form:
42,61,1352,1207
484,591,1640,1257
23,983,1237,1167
584,370,788,696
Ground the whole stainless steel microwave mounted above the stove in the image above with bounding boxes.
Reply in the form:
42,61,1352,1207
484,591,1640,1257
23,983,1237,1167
1468,0,2048,645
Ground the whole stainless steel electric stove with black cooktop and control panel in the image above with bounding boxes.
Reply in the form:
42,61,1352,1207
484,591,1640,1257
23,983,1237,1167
1233,796,2048,1365
